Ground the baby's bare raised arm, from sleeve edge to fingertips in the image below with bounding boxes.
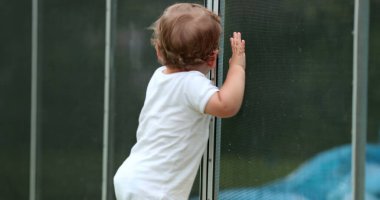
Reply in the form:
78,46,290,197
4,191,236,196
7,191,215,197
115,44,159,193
205,33,245,118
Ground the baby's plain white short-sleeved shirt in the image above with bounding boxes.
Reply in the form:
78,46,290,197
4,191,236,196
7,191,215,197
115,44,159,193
114,67,218,200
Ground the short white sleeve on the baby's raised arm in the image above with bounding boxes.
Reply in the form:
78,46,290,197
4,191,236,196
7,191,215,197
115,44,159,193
185,72,219,113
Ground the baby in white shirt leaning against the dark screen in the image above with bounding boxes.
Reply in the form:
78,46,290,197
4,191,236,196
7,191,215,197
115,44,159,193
114,3,245,200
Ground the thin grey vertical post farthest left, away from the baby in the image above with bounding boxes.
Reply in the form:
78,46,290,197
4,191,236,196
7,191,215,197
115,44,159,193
29,0,38,200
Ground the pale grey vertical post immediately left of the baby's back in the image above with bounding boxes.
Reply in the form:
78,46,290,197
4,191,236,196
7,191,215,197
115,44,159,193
101,0,116,200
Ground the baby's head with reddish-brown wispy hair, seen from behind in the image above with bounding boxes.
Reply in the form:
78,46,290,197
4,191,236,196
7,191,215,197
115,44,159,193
152,3,222,69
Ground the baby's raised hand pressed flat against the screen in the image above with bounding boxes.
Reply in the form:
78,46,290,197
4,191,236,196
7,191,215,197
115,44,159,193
230,32,245,69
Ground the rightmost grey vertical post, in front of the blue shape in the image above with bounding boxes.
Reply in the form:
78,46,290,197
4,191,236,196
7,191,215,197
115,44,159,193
352,0,369,200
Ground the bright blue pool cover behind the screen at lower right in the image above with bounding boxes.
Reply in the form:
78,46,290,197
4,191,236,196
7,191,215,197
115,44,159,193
206,145,380,200
